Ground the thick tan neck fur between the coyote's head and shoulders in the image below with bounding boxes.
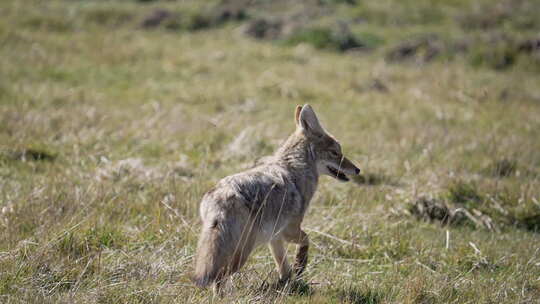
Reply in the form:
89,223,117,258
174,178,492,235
274,132,319,204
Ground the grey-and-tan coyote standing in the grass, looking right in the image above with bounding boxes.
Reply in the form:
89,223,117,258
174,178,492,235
192,104,360,292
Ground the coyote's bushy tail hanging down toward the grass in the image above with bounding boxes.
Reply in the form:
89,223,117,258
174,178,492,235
191,218,238,287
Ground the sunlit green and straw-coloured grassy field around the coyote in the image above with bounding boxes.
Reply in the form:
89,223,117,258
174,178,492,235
0,0,540,303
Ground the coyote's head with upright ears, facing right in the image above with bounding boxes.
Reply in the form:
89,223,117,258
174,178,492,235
295,104,360,182
